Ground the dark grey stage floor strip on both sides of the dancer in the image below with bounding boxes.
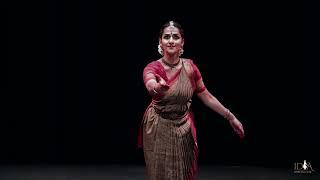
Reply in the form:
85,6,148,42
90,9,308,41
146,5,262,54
0,165,320,180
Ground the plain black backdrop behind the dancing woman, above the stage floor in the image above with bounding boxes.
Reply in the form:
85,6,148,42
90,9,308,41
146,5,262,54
0,1,320,168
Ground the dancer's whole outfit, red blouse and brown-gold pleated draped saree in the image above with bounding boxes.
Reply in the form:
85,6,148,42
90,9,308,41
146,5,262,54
138,59,204,180
